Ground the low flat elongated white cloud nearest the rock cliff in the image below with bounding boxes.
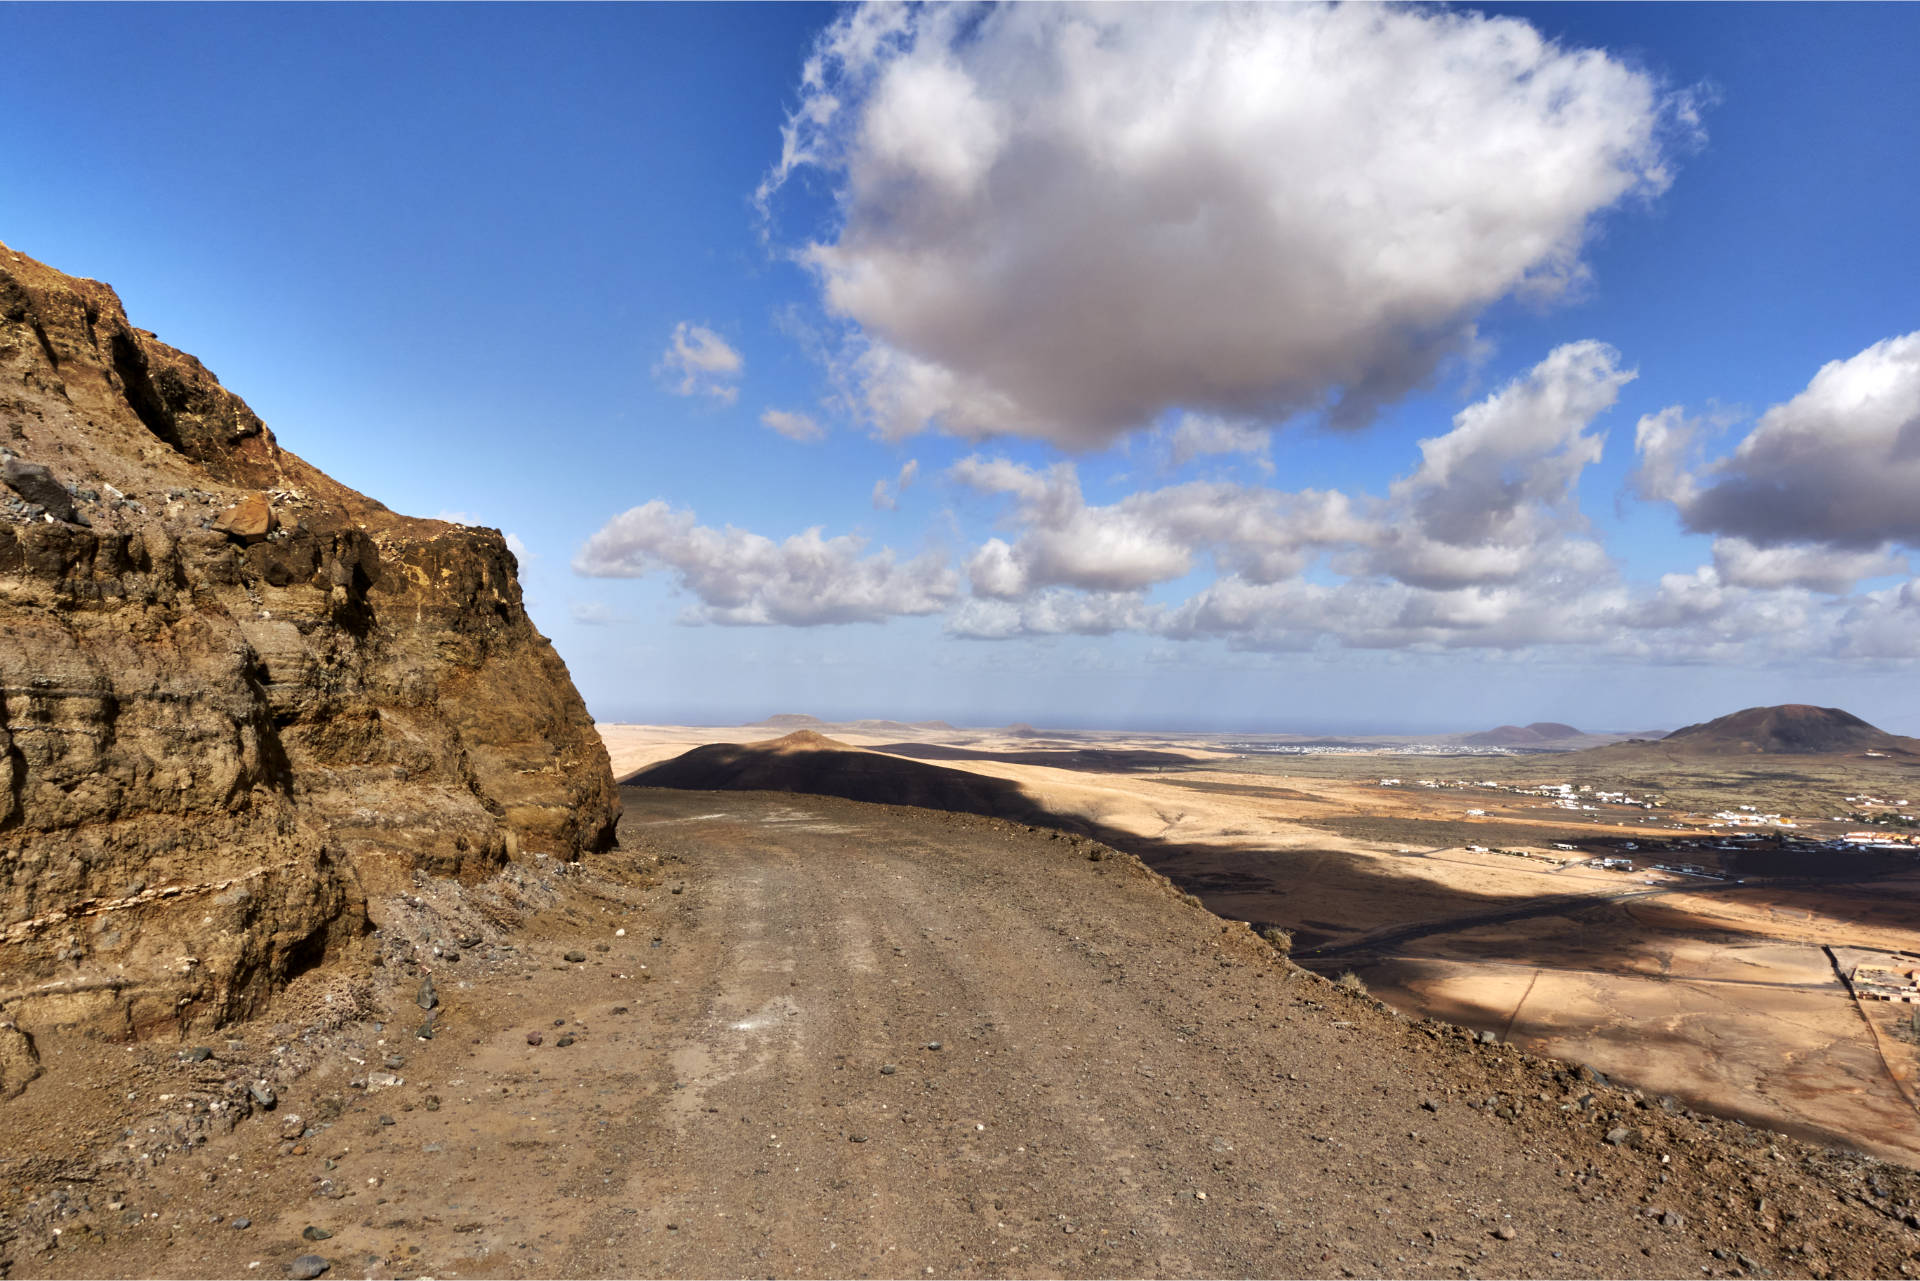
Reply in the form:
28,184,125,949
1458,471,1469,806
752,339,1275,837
574,499,958,626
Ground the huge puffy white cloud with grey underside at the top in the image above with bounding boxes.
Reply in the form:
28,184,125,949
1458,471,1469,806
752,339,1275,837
760,4,1695,447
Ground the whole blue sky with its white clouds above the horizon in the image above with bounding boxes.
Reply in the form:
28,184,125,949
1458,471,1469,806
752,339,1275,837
0,6,1920,732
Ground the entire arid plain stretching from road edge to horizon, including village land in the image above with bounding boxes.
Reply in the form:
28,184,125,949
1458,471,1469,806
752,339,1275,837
599,716,1920,1164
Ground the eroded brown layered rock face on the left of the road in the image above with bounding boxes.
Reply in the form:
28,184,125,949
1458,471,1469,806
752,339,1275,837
0,246,618,1035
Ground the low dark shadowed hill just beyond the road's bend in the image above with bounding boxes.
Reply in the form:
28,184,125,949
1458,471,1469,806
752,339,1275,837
626,730,1073,828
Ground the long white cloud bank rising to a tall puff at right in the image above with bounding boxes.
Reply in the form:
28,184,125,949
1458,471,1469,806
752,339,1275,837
948,342,1634,636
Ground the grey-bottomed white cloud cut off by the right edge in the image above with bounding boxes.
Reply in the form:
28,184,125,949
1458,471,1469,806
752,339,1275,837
1636,332,1920,549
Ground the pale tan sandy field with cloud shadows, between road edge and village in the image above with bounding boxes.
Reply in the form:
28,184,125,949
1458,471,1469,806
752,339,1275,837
601,726,1920,1164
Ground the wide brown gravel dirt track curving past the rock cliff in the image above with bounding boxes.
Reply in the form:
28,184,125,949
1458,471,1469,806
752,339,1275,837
13,789,1920,1277
